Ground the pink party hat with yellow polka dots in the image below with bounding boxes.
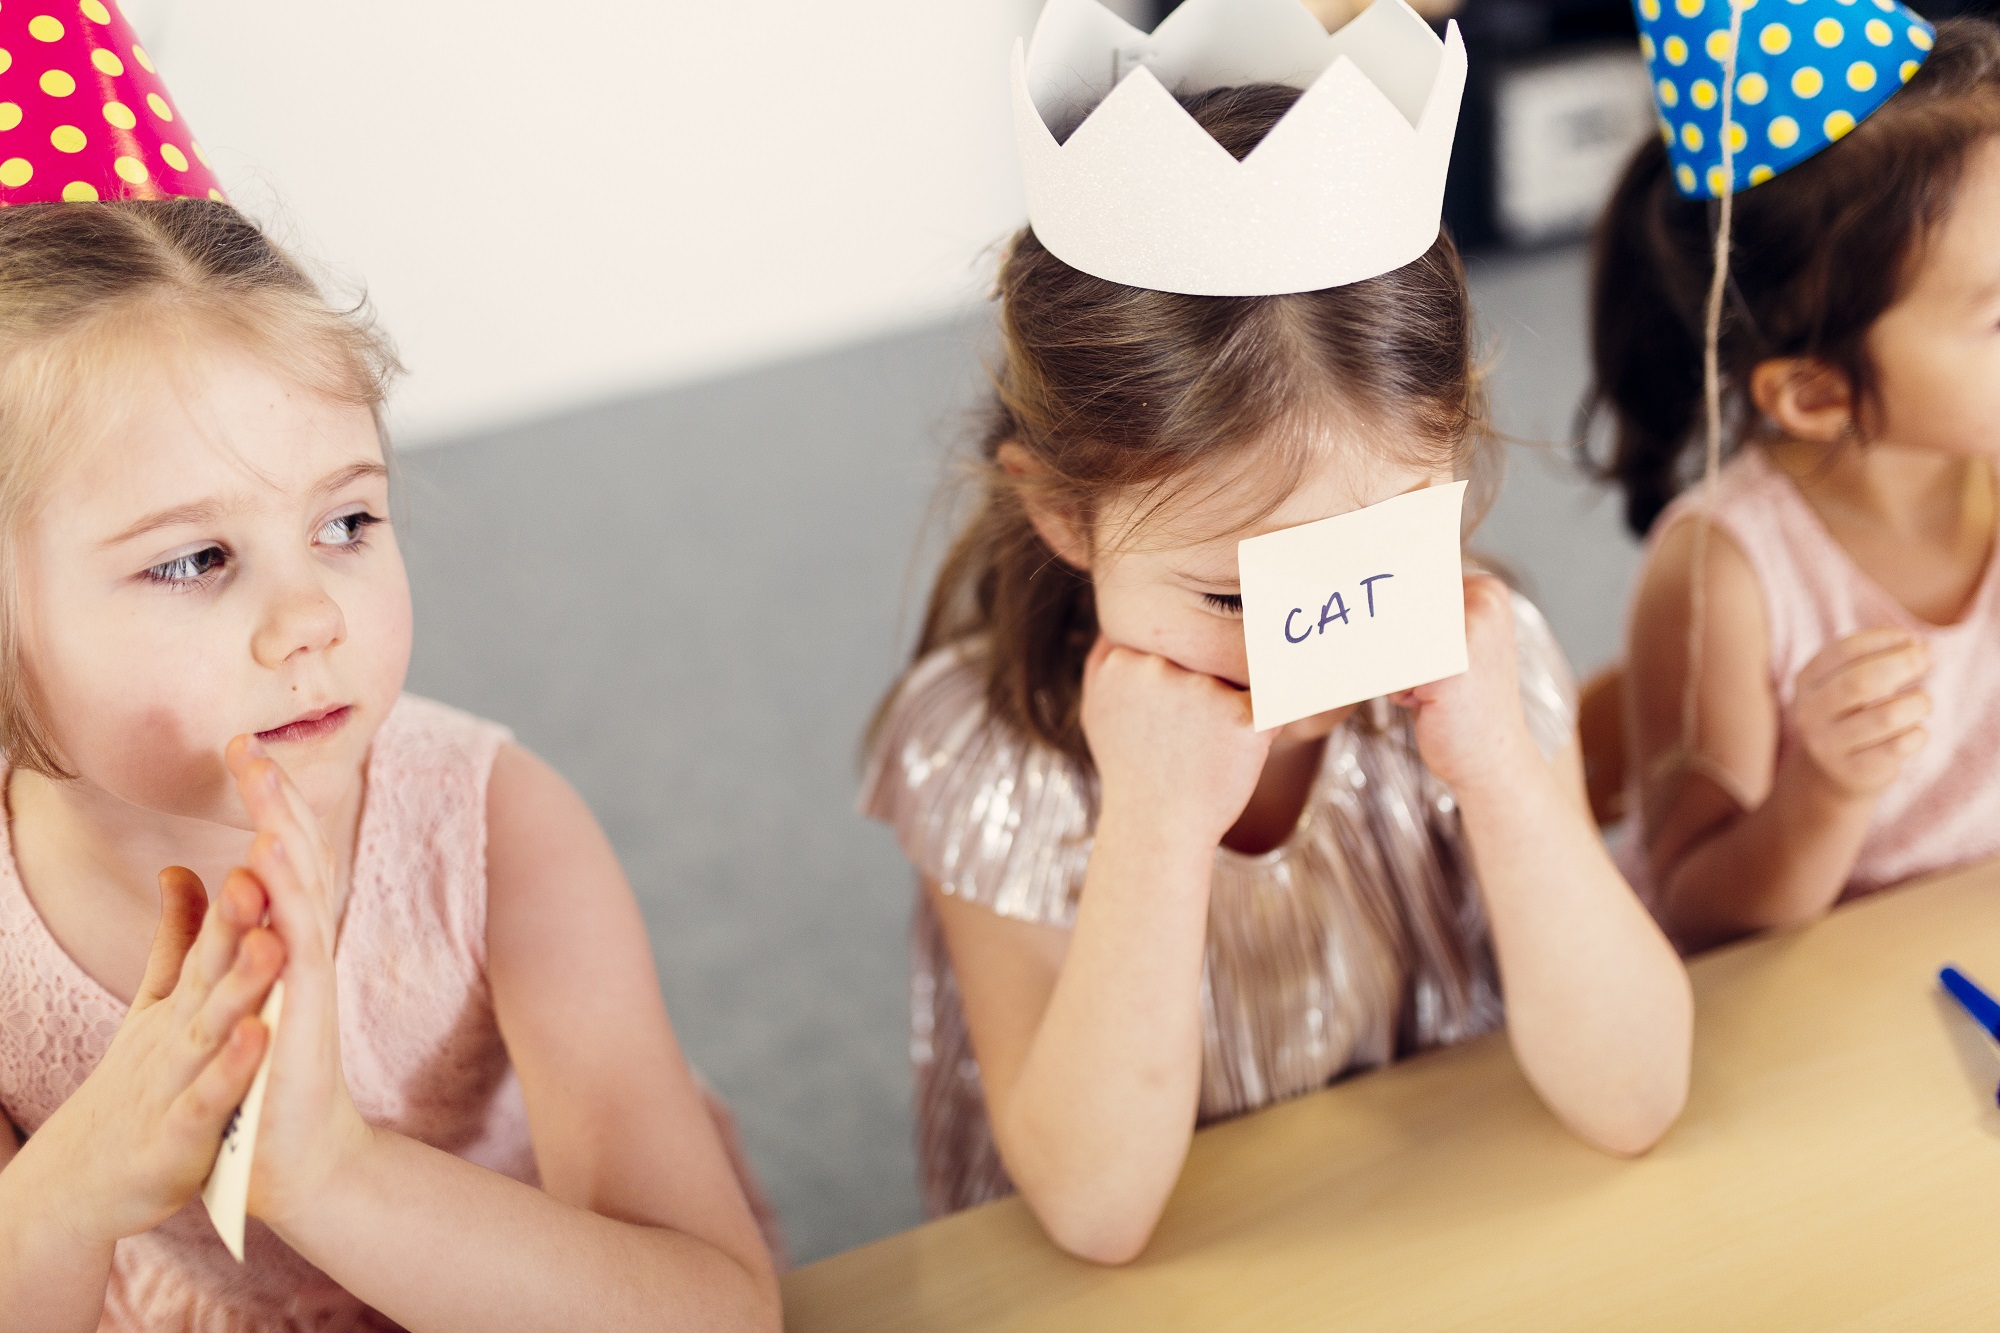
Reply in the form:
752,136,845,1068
0,0,222,206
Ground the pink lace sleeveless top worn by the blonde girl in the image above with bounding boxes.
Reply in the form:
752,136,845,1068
0,695,536,1333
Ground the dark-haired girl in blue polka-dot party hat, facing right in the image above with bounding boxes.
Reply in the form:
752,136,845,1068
1592,0,2000,947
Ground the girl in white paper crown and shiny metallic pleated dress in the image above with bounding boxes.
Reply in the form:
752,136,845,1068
864,0,1692,1263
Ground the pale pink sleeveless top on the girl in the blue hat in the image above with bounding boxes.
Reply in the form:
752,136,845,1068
1654,446,2000,899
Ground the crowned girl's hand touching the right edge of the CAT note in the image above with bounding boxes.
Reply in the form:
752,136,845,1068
1390,574,1540,795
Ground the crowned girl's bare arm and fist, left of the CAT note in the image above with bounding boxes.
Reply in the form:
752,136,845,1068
926,642,1270,1263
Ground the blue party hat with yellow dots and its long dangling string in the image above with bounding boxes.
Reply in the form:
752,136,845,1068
1634,0,1936,788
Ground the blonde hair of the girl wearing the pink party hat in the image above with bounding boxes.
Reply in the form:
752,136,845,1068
0,200,400,777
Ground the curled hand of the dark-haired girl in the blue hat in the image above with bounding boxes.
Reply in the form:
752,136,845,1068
1792,628,1930,799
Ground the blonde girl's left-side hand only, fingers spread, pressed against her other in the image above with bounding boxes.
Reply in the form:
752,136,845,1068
24,867,284,1245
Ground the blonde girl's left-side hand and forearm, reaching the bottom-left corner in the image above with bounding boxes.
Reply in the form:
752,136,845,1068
0,869,284,1333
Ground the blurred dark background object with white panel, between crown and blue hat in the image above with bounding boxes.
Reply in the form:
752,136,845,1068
1156,0,2000,250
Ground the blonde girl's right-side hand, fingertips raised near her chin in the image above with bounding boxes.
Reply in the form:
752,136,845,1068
224,737,370,1231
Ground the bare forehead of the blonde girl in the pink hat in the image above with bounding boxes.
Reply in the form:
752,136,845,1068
48,342,382,510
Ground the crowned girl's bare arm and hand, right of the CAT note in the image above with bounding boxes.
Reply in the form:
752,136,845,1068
1400,578,1694,1153
